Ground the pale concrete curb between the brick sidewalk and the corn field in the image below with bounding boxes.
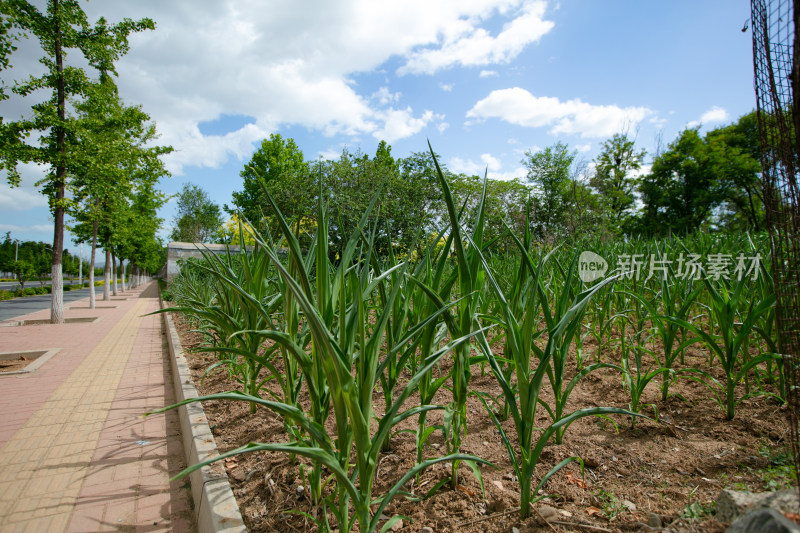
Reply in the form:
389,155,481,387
161,301,247,533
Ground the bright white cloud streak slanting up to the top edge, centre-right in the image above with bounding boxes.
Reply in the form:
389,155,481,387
397,0,555,75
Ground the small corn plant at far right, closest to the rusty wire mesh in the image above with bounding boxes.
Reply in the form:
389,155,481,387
663,279,779,420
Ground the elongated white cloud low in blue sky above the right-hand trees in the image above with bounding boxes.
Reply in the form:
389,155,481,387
467,87,653,138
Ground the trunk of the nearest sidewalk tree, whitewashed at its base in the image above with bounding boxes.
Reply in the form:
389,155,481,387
50,0,67,324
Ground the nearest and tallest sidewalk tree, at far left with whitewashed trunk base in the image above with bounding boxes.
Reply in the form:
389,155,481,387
0,0,155,323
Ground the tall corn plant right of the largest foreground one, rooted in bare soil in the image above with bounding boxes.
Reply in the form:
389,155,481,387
478,231,637,519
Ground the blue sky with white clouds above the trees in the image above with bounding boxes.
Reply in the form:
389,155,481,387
0,0,755,254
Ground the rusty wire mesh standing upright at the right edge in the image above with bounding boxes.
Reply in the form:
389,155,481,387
751,0,800,502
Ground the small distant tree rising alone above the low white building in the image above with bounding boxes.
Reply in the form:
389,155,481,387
170,183,222,243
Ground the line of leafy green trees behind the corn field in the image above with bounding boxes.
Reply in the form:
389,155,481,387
189,113,764,255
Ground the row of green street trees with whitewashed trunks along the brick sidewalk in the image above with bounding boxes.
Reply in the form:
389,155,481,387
0,0,170,323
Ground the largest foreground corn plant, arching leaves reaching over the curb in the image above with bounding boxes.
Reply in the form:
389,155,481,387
151,181,485,532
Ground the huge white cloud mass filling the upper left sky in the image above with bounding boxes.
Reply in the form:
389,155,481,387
45,0,553,173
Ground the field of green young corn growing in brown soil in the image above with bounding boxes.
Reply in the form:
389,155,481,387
153,151,788,532
